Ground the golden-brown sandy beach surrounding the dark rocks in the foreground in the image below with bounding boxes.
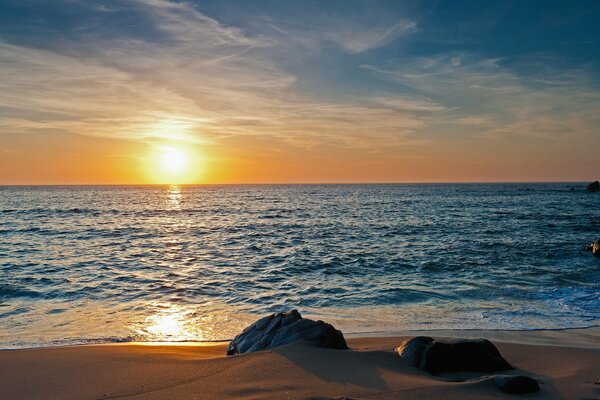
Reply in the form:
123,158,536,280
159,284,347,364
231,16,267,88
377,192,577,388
0,328,600,400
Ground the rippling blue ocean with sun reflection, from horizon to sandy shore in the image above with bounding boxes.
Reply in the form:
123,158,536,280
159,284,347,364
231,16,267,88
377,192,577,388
0,183,600,349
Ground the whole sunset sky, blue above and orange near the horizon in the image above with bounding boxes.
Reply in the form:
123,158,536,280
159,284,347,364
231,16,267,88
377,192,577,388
0,0,600,184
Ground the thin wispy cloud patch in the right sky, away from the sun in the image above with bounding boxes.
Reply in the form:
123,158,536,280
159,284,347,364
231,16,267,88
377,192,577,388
361,52,600,140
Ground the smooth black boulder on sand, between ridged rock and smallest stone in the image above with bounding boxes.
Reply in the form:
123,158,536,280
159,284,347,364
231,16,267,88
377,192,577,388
396,336,513,375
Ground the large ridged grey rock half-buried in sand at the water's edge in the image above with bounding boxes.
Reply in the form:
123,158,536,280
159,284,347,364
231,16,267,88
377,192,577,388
227,310,348,356
